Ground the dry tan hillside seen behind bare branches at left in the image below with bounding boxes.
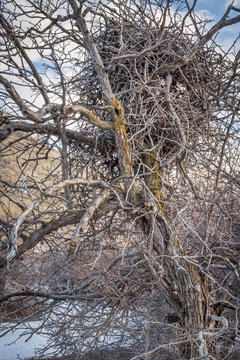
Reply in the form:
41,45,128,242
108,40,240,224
0,132,60,242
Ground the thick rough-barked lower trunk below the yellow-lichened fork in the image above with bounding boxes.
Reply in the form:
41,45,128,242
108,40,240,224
141,214,209,359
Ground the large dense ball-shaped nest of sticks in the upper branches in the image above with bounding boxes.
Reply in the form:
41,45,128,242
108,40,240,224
78,21,225,163
